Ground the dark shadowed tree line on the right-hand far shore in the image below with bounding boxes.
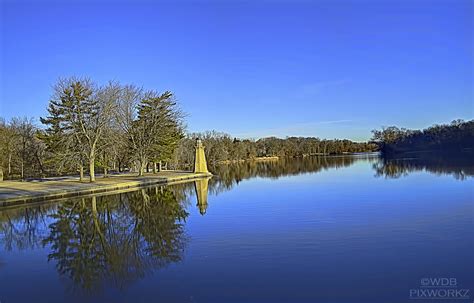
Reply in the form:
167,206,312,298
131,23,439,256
372,120,474,156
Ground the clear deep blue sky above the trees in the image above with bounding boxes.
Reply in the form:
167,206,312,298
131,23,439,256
0,0,474,140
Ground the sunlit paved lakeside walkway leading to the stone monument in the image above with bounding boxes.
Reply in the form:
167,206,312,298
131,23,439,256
0,171,209,207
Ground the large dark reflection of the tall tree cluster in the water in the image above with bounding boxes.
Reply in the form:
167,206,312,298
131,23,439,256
43,187,188,291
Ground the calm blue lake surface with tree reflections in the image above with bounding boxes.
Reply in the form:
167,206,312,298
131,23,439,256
0,155,474,303
